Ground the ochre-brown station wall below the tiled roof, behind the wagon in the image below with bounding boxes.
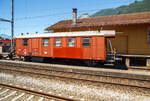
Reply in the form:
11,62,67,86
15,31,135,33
54,24,150,55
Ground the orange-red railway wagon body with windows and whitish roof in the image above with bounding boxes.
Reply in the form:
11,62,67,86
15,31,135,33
15,30,115,64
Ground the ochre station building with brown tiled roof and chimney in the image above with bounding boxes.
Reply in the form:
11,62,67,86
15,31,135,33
45,9,150,68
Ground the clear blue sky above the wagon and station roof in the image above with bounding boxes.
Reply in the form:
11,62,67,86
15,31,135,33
0,0,134,36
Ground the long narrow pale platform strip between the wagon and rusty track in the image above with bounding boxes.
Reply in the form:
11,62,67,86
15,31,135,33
0,60,150,81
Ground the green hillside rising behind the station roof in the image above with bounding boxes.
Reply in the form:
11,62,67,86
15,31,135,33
91,0,150,17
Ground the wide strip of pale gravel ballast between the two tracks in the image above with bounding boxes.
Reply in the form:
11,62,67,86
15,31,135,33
0,71,150,101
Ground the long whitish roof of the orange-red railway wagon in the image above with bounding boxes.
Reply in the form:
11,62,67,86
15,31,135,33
14,30,115,39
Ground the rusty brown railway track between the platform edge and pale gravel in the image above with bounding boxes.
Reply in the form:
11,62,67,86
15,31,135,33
0,64,150,89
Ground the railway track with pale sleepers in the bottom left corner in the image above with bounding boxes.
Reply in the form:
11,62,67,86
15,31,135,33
0,84,77,101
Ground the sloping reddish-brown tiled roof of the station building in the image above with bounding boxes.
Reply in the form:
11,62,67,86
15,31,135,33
45,12,150,31
